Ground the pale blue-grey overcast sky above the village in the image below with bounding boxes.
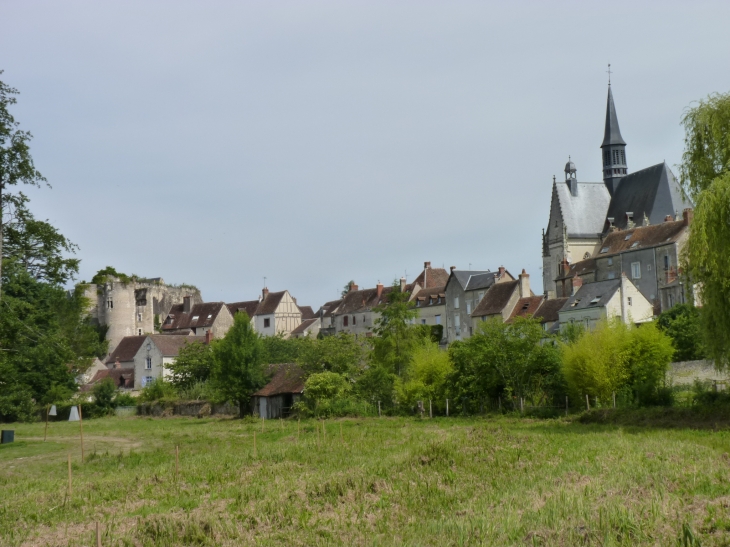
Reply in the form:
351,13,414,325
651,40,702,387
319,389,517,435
0,0,730,309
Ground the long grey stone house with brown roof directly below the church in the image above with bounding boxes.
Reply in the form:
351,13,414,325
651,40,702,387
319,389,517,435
555,209,693,312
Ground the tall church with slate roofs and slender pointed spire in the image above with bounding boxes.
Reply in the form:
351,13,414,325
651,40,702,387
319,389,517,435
542,83,692,298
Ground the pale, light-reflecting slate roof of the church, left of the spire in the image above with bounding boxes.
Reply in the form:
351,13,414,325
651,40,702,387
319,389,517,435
553,182,612,238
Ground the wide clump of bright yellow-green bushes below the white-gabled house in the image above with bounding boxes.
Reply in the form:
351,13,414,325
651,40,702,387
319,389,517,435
563,320,674,405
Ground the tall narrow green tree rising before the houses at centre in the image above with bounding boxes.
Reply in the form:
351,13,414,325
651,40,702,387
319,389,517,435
372,280,423,376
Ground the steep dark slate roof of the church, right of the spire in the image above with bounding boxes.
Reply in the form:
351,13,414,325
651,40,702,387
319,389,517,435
600,162,693,231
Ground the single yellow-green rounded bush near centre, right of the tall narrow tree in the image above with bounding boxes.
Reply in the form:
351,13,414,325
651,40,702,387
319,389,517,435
396,341,454,408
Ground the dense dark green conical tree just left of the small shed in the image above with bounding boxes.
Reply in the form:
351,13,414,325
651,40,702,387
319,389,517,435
212,312,266,417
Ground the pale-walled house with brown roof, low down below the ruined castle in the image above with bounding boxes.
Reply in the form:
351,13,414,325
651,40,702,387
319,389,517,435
133,330,206,389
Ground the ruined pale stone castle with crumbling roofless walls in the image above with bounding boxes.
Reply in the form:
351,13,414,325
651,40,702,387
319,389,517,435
84,276,203,353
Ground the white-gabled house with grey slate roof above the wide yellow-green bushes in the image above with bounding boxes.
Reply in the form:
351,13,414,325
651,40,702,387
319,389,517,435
558,274,654,330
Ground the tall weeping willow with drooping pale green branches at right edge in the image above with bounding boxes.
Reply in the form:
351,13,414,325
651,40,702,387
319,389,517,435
679,93,730,367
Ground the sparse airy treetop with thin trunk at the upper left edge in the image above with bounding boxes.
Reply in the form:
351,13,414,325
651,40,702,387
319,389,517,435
0,71,46,298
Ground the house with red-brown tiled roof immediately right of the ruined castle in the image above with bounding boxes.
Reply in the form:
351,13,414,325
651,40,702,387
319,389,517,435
162,296,233,338
